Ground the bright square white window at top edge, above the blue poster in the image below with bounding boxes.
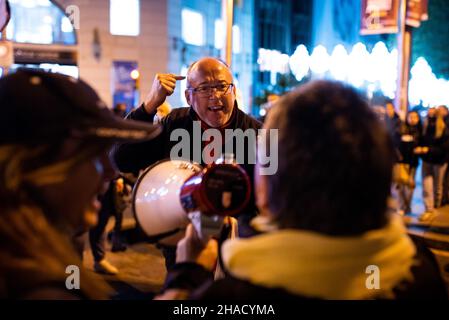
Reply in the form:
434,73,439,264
109,0,140,36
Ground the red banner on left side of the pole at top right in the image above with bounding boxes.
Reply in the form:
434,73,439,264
360,0,400,35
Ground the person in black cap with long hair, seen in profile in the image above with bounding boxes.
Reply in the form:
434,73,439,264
0,70,160,299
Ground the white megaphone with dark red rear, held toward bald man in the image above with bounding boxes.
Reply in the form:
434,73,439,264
132,158,251,245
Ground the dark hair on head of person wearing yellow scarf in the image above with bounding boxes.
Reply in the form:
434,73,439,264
268,81,393,235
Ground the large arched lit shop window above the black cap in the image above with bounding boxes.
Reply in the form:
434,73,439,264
6,0,79,77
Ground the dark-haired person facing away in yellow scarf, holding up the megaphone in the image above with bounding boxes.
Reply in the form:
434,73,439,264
158,81,447,301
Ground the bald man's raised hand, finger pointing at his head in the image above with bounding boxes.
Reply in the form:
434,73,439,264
144,73,185,114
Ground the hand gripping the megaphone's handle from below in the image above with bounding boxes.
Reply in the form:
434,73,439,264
176,224,218,271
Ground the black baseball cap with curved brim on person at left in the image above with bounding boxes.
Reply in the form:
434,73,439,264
0,69,162,145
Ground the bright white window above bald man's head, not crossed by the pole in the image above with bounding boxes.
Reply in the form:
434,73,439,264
181,9,204,46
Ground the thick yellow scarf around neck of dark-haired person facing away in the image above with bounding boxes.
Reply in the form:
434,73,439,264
222,217,416,299
